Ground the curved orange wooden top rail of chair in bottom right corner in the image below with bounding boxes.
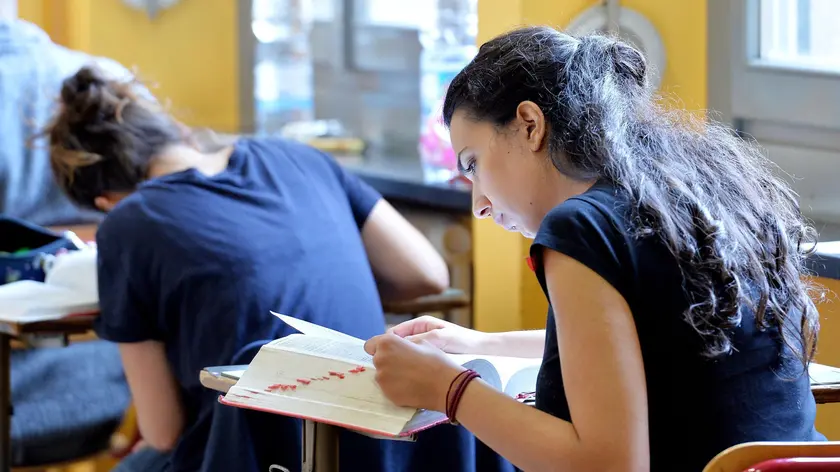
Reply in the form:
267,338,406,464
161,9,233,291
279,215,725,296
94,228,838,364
703,441,840,472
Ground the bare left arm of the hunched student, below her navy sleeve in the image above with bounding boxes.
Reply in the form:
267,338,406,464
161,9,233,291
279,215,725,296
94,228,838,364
119,341,184,451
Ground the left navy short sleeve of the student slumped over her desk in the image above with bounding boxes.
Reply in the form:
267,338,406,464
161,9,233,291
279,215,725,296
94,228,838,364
94,197,161,343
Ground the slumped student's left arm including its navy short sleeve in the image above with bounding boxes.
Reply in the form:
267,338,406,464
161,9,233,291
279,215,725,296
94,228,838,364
94,205,185,451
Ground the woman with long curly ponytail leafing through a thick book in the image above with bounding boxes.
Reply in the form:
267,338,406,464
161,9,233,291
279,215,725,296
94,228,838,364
366,27,824,472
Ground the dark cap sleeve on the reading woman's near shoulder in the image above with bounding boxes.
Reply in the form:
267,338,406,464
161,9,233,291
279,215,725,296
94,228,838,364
530,198,628,298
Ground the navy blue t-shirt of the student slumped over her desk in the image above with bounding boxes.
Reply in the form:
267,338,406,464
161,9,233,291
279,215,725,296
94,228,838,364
96,139,384,470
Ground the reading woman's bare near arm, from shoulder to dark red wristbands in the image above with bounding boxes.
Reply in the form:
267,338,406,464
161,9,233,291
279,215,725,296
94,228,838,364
456,250,650,472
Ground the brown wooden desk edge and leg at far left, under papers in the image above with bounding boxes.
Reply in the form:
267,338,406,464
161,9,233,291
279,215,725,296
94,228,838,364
0,315,96,472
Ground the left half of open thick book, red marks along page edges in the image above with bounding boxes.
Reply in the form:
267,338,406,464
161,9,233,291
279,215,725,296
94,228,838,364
225,342,417,436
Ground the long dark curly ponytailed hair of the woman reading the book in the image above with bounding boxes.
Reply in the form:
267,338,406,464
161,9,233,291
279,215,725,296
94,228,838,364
444,27,819,365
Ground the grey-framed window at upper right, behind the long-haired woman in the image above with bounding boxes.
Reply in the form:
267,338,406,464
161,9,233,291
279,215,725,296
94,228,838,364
708,0,840,223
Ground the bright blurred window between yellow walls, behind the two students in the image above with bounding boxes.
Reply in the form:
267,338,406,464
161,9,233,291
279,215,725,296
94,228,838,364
240,0,478,160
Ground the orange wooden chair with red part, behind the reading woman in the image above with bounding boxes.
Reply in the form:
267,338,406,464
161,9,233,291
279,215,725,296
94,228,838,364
703,441,840,472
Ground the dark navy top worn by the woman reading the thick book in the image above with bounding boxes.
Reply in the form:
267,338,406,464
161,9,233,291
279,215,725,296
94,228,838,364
531,182,825,472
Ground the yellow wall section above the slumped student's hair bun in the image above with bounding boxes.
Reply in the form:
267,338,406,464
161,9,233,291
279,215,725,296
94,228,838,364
19,0,240,132
